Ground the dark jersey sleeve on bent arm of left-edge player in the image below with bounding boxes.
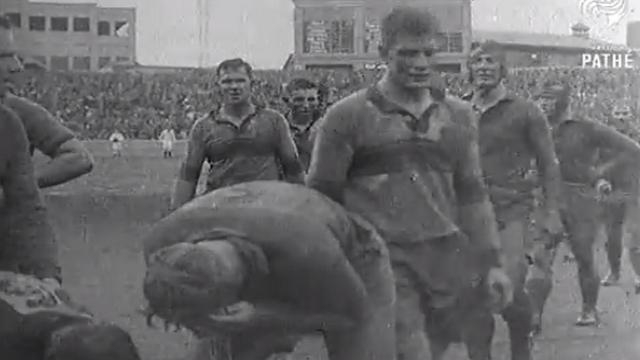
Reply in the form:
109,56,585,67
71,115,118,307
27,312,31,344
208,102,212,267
9,97,75,156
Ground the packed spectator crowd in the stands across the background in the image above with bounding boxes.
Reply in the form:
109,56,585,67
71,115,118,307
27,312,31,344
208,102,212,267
12,68,640,140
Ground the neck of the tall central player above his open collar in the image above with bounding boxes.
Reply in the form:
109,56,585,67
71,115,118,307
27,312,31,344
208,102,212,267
377,73,433,116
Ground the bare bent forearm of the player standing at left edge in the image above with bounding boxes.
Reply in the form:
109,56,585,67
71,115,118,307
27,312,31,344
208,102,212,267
36,153,93,188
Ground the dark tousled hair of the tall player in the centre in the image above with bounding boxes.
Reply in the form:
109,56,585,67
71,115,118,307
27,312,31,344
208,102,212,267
380,6,440,56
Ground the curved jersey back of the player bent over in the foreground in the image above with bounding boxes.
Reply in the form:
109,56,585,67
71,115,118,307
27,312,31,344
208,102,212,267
144,181,395,360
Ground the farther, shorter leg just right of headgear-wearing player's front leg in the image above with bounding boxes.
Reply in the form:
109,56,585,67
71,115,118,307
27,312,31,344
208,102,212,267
601,203,626,286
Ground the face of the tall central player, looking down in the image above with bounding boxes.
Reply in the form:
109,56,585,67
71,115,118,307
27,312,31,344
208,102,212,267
385,34,437,89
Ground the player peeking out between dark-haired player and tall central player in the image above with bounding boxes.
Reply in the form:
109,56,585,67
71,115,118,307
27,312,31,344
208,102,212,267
285,78,322,171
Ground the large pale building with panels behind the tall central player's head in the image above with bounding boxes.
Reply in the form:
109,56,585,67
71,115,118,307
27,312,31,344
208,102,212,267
285,0,471,72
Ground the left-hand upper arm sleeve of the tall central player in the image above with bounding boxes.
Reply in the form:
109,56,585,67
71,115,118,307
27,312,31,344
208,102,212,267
306,103,354,203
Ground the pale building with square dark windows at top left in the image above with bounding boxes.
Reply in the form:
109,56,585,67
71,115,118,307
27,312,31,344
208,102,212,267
0,0,136,71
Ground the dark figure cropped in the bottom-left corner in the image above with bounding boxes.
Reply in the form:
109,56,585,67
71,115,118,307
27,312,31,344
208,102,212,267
0,271,140,360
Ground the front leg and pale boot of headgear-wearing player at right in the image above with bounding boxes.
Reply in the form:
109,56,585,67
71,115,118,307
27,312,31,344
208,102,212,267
563,189,603,326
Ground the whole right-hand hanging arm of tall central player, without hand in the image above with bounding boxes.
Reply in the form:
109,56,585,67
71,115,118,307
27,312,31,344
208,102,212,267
453,107,502,270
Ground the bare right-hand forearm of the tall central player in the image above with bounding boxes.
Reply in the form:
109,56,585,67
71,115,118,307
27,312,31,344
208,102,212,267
459,200,502,270
